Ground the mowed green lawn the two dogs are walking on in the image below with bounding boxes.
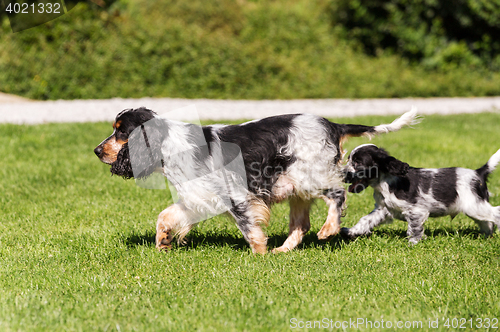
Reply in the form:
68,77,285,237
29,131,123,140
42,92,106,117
0,113,500,331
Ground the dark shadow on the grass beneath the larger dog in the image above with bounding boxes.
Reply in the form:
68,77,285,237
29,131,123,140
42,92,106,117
124,232,348,251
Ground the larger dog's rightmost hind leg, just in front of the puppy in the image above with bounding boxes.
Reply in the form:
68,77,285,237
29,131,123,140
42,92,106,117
318,188,346,240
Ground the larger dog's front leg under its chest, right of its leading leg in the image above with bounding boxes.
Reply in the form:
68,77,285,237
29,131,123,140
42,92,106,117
230,201,270,255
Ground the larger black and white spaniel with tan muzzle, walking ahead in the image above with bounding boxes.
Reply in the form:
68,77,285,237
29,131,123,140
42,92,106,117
94,108,416,254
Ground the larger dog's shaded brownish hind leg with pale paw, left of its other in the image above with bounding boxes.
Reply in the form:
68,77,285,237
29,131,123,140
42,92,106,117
273,198,311,253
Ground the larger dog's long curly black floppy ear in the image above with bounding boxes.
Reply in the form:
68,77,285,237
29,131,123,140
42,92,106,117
128,118,168,178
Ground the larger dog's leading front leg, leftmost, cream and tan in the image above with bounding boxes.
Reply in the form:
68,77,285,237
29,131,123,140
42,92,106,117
156,204,192,250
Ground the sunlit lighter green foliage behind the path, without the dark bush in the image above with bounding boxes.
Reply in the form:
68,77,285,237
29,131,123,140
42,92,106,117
0,0,500,99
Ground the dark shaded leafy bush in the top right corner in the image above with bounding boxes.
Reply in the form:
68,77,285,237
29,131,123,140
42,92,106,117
330,0,500,70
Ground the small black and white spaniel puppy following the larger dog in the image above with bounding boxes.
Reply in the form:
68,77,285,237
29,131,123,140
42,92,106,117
341,144,500,244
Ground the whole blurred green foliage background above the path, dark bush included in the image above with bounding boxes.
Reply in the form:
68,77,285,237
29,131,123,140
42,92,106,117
0,0,500,99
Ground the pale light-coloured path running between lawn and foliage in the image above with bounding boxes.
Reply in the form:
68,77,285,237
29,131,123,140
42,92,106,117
0,94,500,124
